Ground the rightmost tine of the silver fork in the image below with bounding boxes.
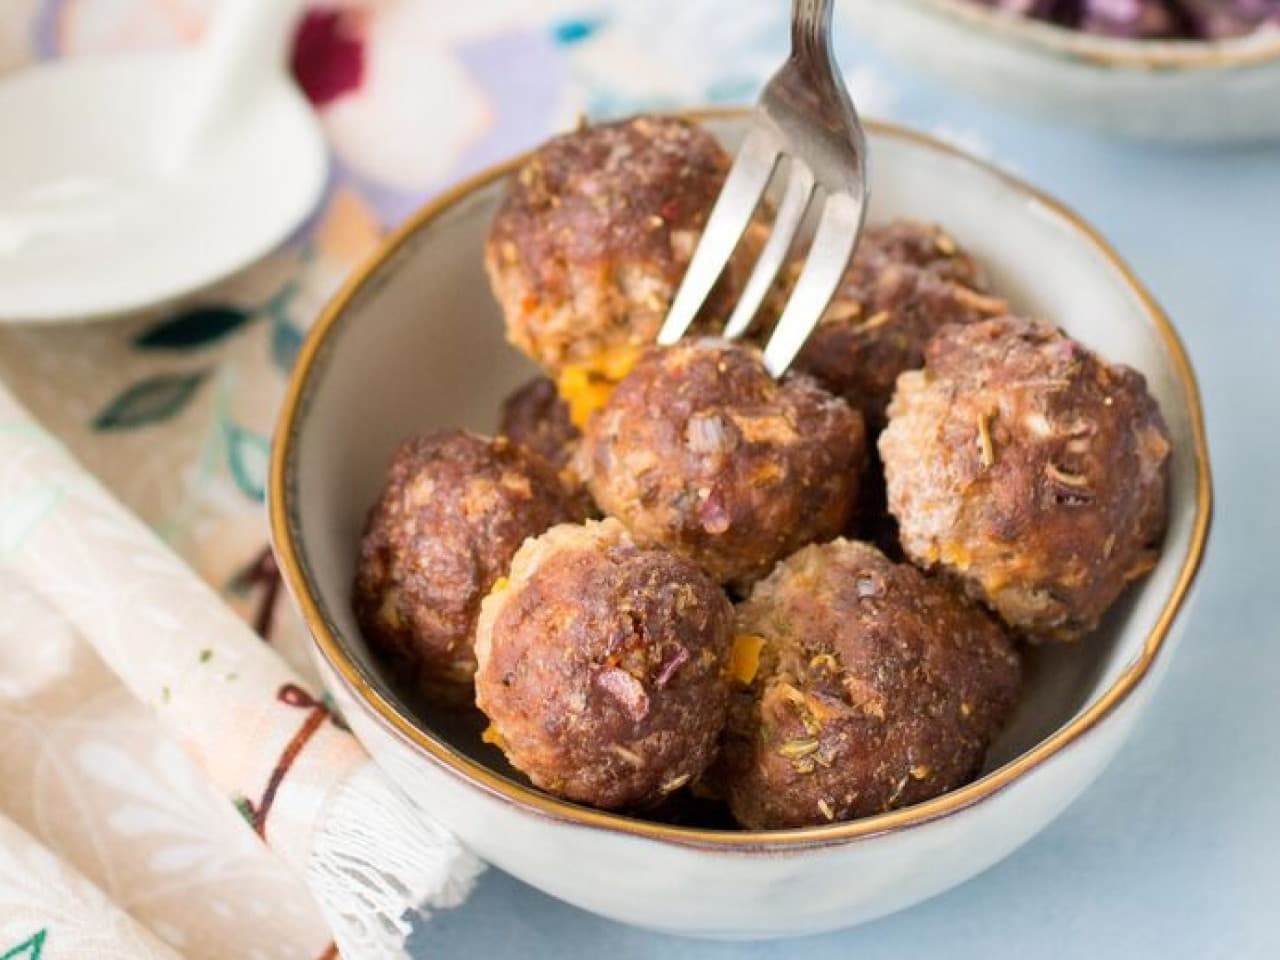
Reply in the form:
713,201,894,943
764,193,864,376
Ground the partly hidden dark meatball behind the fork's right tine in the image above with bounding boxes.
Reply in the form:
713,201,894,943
796,220,1006,431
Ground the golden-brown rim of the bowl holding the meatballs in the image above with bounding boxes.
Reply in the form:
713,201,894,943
268,108,1212,852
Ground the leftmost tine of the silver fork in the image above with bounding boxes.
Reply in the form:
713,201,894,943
658,127,778,344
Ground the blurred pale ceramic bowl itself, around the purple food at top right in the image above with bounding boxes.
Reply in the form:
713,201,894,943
844,0,1280,142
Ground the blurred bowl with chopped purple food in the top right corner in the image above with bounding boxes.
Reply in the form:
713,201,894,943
845,0,1280,143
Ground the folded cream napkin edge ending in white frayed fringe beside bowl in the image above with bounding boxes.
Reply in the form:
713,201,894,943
0,378,476,960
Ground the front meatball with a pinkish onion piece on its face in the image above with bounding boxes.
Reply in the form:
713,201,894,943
476,518,732,808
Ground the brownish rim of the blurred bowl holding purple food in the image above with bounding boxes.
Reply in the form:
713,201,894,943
906,0,1280,73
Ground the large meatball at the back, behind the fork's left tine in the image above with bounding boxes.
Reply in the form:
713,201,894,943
485,116,760,375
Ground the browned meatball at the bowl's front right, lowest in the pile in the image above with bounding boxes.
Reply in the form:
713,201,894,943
717,540,1020,829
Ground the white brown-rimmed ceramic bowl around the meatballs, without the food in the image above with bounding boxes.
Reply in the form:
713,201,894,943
270,114,1210,938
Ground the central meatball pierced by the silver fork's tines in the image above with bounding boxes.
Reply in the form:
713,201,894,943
580,339,865,588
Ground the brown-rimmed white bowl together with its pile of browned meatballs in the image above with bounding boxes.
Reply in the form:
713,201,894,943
270,111,1211,938
